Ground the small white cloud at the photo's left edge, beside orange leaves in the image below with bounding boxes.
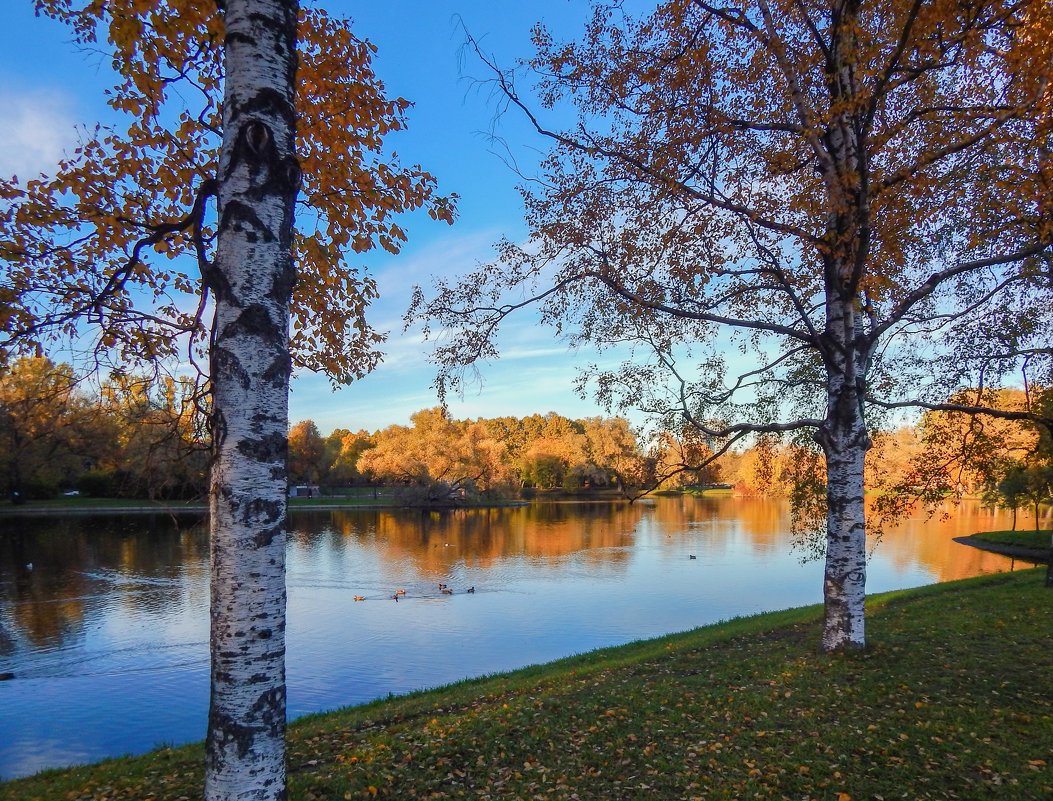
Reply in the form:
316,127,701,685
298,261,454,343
0,88,76,180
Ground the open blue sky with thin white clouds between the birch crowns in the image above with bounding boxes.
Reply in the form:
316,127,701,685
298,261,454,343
0,0,627,433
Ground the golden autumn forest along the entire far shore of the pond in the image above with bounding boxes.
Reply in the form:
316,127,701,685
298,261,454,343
0,358,1053,517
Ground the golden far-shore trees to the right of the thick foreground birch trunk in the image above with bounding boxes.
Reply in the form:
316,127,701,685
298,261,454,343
290,388,1053,523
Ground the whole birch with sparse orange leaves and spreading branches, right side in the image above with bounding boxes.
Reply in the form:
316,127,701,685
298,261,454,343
409,0,1053,650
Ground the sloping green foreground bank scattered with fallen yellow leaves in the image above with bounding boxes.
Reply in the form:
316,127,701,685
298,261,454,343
0,570,1053,801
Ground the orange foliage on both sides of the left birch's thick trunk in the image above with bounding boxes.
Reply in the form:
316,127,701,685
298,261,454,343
0,0,455,382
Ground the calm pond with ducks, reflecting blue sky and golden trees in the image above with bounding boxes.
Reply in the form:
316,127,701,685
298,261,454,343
0,497,1011,779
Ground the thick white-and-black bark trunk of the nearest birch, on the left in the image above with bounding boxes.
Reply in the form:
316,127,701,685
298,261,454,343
205,0,300,801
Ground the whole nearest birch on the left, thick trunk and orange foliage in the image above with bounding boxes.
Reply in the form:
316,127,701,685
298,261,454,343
0,0,452,801
